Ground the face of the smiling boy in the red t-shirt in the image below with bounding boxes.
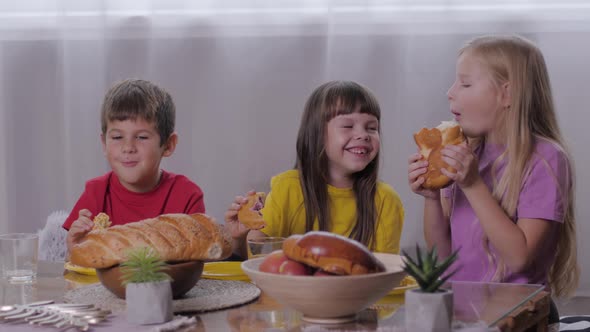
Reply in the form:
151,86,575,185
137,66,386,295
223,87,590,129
101,118,177,193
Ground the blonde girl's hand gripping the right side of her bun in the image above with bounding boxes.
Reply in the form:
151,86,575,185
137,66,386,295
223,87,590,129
441,143,481,189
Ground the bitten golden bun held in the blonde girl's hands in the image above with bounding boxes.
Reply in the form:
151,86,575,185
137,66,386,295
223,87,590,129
414,121,465,189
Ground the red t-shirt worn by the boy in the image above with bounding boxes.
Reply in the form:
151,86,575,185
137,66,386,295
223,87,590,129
63,171,205,229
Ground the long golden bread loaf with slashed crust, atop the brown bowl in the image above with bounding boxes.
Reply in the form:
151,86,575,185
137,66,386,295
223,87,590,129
70,213,232,268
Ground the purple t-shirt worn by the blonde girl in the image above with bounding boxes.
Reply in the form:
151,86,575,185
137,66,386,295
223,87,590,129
443,140,571,284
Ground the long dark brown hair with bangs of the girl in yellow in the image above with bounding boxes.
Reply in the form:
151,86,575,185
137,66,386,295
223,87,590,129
295,81,381,249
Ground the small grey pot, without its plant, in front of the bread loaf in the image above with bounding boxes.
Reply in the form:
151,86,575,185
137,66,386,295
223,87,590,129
125,280,172,325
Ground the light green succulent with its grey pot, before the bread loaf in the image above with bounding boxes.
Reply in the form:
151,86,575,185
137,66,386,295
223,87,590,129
121,247,172,325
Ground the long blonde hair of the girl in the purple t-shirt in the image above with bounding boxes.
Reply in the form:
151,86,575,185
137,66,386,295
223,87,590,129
460,36,580,296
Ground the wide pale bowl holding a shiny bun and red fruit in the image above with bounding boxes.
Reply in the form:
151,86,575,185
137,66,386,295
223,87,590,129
242,253,406,323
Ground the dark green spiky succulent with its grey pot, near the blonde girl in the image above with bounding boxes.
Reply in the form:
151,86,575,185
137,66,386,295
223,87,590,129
402,245,457,332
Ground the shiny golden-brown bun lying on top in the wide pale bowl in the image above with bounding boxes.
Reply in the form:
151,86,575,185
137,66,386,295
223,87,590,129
283,231,385,275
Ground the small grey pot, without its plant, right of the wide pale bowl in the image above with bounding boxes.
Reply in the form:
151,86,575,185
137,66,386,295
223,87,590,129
405,289,453,332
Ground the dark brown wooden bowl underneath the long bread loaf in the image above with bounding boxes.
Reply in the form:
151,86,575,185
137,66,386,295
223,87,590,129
96,261,203,299
